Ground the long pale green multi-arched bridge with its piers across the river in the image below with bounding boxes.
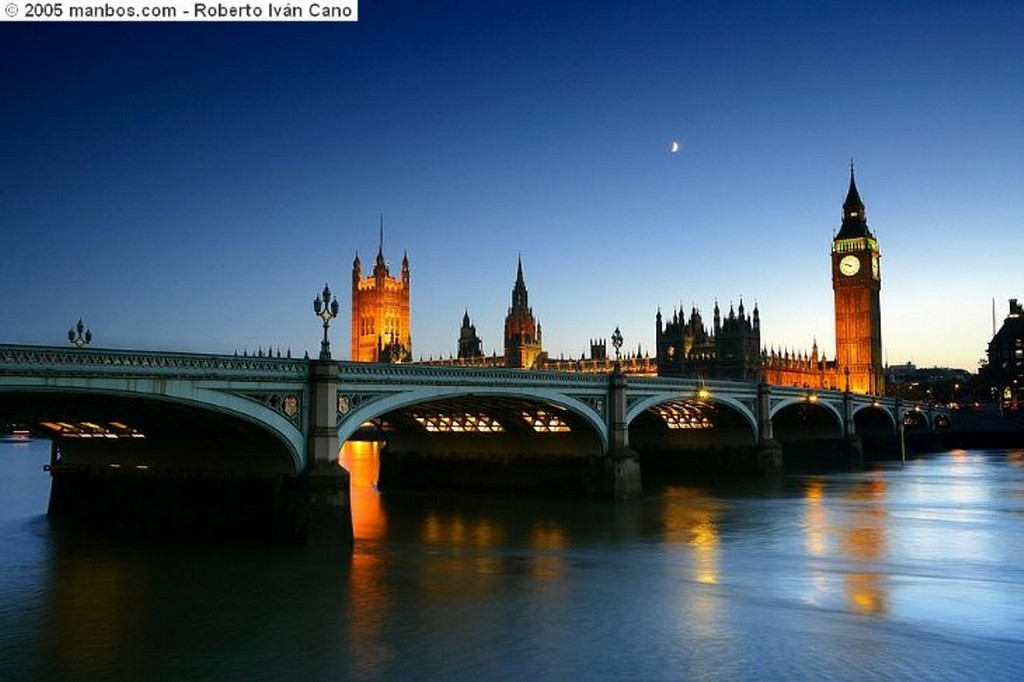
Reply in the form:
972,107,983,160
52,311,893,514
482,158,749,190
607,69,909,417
0,345,949,544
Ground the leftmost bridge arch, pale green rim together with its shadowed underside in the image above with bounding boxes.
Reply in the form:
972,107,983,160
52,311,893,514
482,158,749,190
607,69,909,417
0,377,306,474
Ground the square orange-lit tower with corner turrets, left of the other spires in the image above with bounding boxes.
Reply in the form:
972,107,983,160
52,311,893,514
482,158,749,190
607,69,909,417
351,218,413,363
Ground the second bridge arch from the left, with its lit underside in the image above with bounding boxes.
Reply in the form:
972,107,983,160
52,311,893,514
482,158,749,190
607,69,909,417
337,386,608,492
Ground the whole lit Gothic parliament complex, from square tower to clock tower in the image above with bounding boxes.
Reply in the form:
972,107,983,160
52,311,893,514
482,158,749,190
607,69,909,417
351,164,885,394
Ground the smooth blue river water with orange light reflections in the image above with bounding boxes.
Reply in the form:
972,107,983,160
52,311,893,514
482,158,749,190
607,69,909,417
0,442,1024,680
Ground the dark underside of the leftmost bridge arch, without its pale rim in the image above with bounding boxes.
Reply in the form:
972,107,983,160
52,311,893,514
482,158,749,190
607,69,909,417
0,390,301,475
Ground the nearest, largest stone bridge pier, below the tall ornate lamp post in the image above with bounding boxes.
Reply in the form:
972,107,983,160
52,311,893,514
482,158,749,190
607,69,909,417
296,359,352,546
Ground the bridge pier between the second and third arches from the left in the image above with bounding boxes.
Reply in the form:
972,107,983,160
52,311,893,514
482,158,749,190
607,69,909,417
587,363,643,498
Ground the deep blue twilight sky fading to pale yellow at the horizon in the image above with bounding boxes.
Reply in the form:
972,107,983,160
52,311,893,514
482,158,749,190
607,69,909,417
0,0,1024,370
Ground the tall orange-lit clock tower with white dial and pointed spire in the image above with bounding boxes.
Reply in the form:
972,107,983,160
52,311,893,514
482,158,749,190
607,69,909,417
831,163,885,394
